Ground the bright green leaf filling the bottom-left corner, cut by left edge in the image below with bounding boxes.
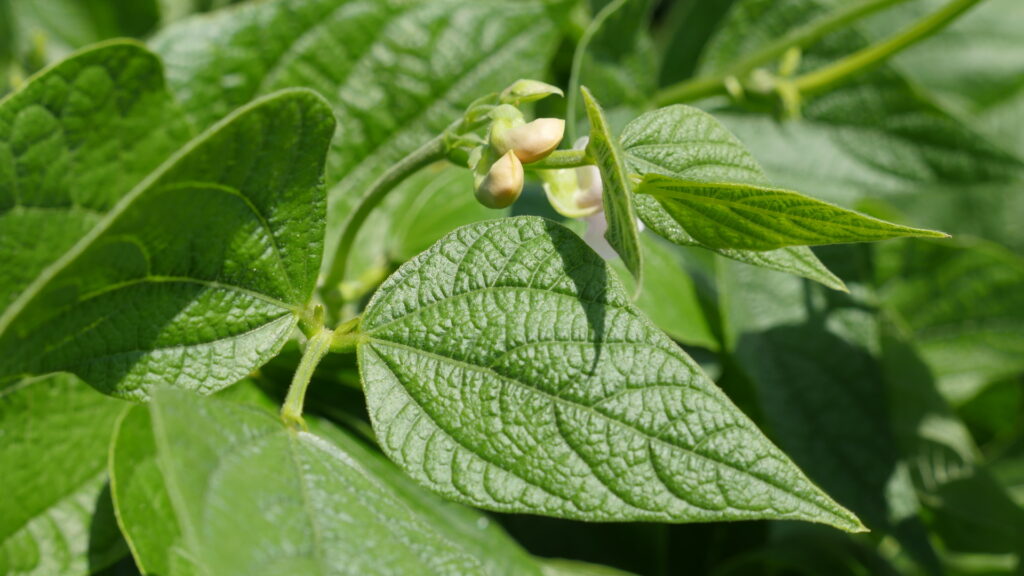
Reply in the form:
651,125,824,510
0,374,128,576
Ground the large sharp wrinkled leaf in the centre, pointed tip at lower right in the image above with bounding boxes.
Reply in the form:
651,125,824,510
357,216,861,531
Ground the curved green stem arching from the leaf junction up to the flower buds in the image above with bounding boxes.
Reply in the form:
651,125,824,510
324,131,446,314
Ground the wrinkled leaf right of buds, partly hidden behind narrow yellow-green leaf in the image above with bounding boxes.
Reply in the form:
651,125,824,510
622,106,845,290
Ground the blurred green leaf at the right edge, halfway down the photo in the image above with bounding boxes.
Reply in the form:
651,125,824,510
880,240,1024,404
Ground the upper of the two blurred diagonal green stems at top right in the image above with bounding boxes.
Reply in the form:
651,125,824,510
654,0,907,107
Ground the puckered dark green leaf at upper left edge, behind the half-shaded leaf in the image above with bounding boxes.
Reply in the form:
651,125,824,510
0,42,191,313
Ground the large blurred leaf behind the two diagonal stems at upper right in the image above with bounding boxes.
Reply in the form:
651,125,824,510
702,0,1024,205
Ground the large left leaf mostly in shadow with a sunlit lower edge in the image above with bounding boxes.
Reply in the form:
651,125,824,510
0,90,334,399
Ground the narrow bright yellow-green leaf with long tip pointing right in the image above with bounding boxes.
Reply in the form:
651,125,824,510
637,174,948,250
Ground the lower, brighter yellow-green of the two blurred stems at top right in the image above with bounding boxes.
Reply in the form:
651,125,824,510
794,0,981,95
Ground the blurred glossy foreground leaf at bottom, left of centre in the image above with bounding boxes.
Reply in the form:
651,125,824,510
111,390,538,576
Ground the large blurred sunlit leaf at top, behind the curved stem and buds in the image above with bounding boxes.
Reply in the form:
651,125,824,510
153,0,570,265
